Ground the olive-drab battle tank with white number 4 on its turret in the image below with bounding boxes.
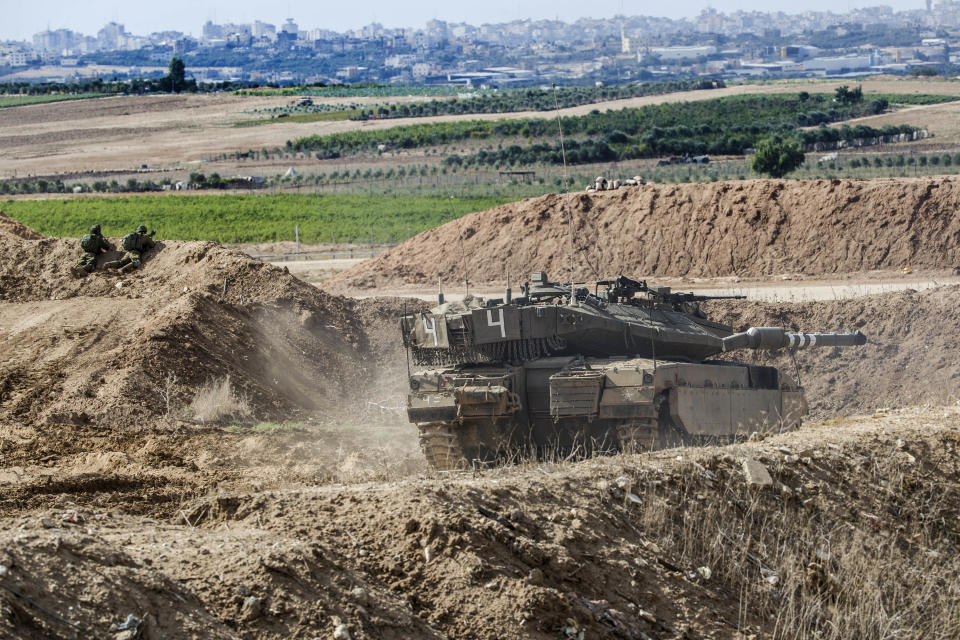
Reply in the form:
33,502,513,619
401,272,866,470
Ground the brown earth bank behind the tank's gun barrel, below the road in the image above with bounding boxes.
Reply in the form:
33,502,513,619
705,286,960,420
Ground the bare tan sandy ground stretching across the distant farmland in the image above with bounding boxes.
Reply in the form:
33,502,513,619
0,79,960,176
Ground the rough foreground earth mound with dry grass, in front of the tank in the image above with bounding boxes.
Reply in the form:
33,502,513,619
0,408,960,640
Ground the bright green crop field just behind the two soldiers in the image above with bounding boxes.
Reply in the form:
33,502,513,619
0,193,510,243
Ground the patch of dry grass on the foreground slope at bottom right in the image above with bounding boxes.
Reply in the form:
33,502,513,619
634,442,960,640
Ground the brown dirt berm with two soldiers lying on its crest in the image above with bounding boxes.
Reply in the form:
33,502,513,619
0,211,420,427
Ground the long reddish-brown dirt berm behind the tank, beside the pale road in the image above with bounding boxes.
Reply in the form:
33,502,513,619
324,177,960,291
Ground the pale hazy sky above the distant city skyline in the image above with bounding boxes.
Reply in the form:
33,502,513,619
0,0,924,40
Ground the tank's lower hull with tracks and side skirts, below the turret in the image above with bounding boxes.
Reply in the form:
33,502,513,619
407,356,807,469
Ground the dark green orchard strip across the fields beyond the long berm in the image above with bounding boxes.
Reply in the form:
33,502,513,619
287,90,957,165
